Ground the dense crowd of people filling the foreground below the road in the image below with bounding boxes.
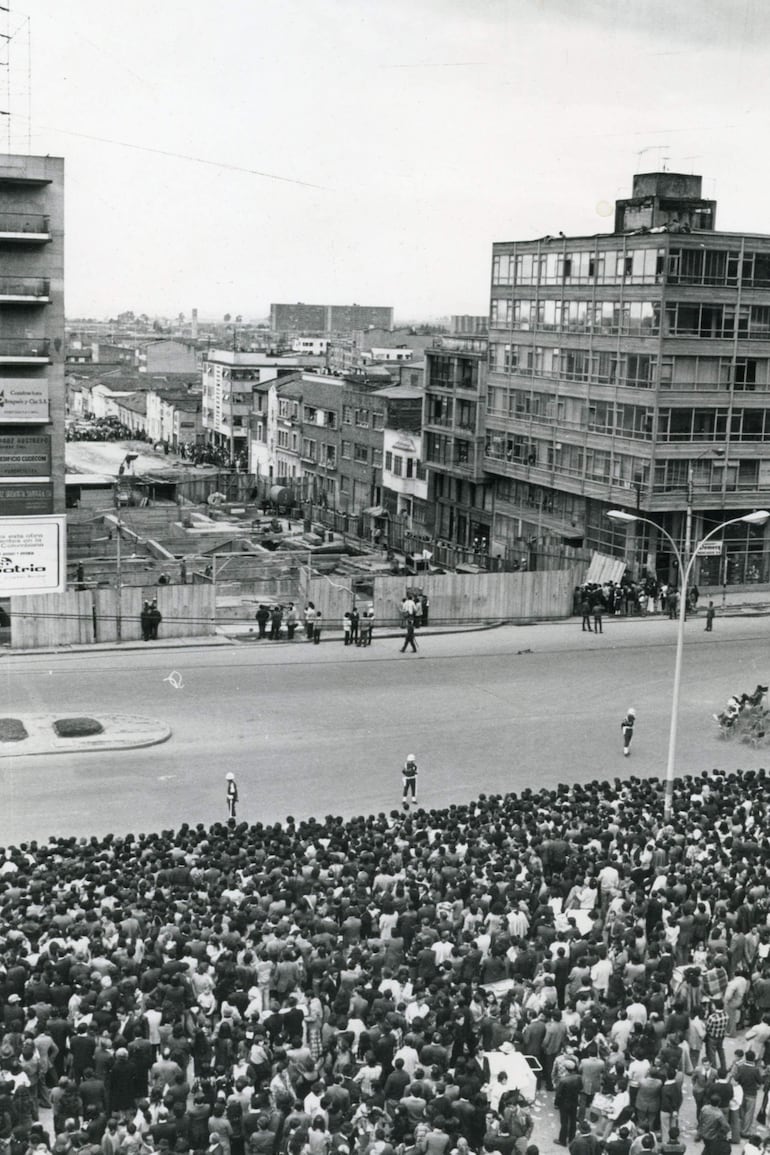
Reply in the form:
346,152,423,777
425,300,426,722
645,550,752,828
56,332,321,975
0,770,770,1155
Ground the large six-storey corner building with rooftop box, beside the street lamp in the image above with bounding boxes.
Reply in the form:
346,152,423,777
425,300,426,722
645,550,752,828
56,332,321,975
484,172,770,586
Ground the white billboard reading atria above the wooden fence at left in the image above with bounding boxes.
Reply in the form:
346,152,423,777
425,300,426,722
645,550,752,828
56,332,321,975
0,515,67,597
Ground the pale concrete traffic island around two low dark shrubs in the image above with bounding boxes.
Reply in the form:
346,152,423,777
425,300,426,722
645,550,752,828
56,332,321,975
0,711,171,759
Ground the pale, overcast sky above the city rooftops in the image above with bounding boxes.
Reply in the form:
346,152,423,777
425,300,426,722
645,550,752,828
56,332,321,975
9,0,770,321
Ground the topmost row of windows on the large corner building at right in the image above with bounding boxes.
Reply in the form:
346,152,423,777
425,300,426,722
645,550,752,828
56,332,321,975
492,245,770,289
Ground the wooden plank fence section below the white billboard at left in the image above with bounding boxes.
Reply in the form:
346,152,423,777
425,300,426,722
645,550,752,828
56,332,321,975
10,583,216,649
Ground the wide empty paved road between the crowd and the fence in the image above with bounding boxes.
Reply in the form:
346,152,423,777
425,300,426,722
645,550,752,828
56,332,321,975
0,618,770,841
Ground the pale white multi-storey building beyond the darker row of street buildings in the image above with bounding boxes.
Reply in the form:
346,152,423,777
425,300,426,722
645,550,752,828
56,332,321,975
203,349,298,464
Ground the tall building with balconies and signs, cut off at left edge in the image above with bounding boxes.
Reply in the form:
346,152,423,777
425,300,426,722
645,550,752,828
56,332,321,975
0,155,65,531
